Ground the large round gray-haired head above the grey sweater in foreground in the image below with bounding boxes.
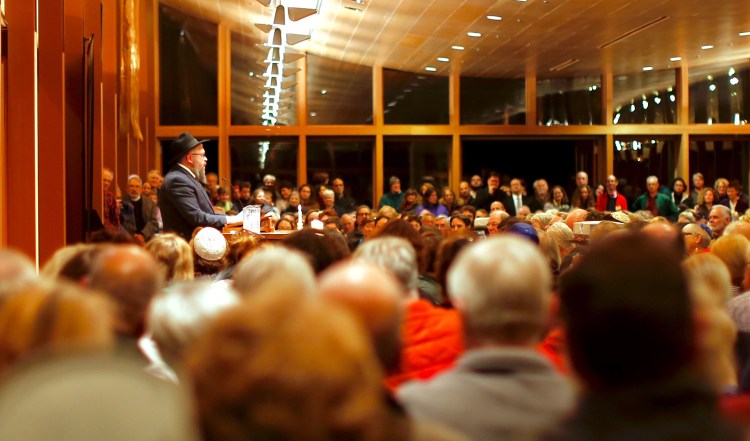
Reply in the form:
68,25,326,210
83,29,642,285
447,235,552,344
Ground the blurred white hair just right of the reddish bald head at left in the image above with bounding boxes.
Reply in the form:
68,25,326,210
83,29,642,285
147,281,240,359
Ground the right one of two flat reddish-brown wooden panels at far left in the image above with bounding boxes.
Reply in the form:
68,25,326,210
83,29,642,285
38,0,67,265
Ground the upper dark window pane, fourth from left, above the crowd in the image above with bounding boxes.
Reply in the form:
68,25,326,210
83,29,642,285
383,69,449,124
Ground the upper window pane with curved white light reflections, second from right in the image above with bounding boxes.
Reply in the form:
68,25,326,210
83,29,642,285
612,69,677,124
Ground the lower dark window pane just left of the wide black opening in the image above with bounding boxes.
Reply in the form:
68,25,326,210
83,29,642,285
383,137,451,192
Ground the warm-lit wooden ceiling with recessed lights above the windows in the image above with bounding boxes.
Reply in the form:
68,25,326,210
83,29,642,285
162,0,750,78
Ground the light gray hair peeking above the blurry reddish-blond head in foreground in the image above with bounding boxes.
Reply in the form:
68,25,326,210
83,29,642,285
232,245,316,297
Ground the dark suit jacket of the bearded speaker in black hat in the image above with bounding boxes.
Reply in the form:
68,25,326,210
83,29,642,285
159,165,227,241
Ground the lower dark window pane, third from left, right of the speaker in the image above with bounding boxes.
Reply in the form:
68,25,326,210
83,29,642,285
307,138,375,205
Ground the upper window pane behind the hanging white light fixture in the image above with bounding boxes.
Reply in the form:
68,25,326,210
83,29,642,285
231,31,299,126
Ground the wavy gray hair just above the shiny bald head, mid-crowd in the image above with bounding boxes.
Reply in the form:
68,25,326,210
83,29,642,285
354,237,419,291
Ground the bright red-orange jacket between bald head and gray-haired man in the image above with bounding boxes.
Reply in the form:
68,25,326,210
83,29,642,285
385,300,464,391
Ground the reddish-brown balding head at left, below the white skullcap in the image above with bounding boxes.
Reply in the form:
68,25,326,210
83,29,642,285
90,245,164,338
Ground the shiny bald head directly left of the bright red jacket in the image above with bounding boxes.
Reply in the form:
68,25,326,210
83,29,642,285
318,262,404,370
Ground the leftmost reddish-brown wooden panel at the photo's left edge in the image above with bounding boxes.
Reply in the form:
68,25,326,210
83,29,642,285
5,1,38,262
